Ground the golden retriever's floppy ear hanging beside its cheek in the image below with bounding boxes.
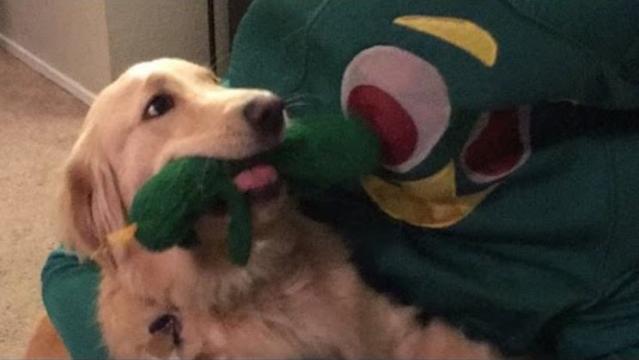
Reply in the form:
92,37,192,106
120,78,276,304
61,139,126,266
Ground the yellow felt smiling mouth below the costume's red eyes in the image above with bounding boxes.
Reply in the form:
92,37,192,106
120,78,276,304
362,161,497,228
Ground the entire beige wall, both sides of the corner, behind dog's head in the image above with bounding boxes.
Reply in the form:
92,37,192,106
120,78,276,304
0,0,210,103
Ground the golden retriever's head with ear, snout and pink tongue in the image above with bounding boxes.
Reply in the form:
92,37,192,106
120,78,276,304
63,59,284,266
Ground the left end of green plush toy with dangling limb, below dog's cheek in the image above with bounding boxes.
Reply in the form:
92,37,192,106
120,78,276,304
129,157,251,265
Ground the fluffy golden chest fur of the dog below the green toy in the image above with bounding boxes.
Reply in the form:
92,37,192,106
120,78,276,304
99,215,413,358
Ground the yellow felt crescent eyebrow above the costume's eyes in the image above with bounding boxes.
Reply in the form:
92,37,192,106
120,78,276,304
393,15,498,67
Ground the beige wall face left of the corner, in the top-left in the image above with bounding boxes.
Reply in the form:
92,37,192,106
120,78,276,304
0,0,112,101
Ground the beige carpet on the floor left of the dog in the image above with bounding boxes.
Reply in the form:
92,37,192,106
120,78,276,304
0,49,87,358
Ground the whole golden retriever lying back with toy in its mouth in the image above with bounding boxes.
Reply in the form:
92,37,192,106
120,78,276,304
30,59,497,359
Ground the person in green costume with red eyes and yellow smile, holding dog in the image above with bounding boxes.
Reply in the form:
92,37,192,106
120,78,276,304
43,0,639,359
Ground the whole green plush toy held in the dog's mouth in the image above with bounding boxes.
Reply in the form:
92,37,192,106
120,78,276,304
129,116,379,265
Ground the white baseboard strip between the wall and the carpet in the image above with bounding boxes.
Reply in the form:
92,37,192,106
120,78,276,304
0,34,95,105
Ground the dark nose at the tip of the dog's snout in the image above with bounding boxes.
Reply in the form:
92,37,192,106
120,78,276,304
243,96,284,136
